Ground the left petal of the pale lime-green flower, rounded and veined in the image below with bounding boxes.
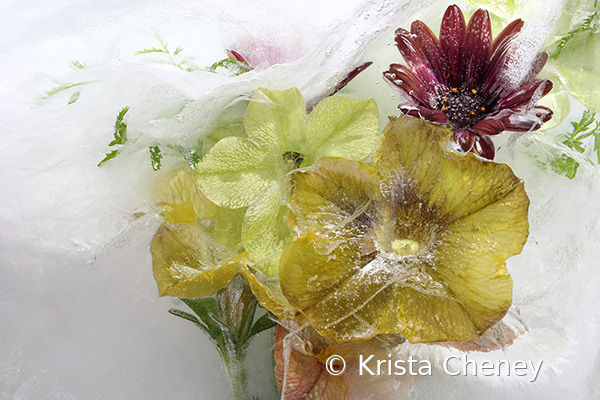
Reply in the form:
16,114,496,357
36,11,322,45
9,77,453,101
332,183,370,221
194,137,277,208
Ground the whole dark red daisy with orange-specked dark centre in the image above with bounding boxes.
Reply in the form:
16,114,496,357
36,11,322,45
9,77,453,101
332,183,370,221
383,5,552,160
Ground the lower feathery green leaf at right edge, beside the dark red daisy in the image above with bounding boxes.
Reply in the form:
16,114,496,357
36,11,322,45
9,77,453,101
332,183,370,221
550,110,600,179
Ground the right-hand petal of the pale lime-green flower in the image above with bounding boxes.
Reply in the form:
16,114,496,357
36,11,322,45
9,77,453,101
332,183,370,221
302,96,379,165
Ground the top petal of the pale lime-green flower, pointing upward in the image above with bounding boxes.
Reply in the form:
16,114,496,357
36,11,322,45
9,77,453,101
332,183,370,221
244,88,306,150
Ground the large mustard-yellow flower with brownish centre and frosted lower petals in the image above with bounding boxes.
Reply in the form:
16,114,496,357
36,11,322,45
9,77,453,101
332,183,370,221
279,117,529,342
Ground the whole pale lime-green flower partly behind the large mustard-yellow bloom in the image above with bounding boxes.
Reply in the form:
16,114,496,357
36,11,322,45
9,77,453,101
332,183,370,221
194,88,379,275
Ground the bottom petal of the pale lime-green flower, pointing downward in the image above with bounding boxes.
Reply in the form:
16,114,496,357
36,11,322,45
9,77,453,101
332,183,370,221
242,184,293,274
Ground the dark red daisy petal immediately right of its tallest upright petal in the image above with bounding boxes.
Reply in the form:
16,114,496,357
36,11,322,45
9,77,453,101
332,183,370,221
462,9,492,89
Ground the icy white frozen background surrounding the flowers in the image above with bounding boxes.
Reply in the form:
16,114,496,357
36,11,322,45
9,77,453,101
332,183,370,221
0,0,600,400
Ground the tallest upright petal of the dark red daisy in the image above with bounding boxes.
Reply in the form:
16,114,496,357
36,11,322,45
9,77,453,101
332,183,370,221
440,5,466,87
